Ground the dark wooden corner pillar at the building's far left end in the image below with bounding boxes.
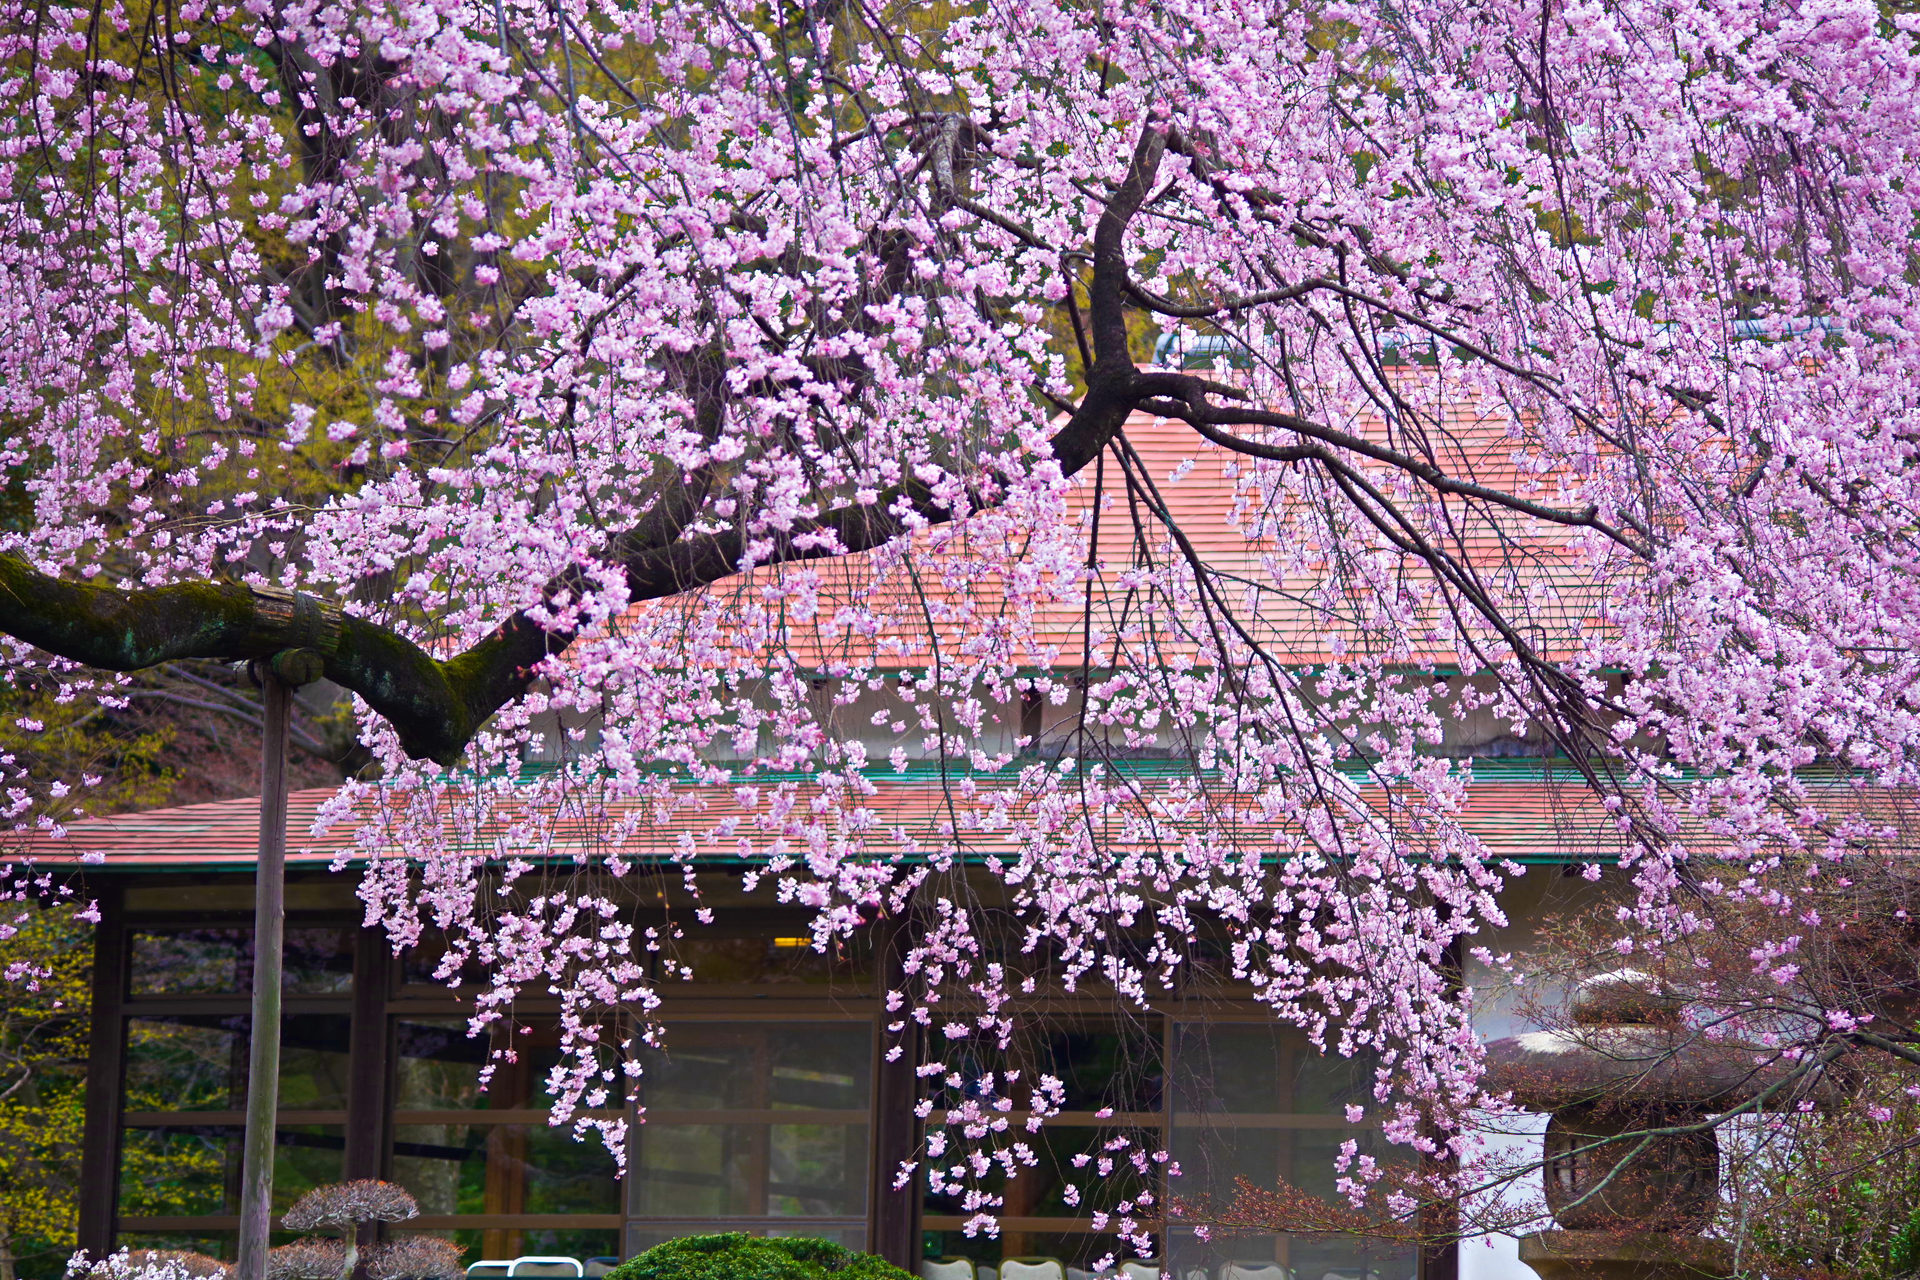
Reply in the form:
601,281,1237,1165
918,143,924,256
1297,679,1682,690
79,881,127,1257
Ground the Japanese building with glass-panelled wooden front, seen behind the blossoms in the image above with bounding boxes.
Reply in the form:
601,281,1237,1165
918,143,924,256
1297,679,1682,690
38,418,1603,1280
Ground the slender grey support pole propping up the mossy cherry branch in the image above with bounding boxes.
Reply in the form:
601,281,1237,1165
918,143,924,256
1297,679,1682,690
234,662,290,1280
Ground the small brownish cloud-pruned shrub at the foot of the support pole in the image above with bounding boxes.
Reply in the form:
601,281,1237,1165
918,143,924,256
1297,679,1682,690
267,1178,463,1280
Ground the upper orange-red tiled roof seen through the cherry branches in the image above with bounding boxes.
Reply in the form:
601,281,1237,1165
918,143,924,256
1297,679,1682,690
626,391,1605,672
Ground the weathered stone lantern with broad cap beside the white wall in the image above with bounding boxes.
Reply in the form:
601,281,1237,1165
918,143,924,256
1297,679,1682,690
1488,971,1770,1280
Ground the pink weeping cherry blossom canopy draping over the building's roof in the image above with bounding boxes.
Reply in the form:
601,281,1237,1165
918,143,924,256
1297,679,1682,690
0,0,1920,1258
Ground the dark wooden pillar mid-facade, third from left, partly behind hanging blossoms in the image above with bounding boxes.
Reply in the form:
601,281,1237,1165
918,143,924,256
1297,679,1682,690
866,921,920,1270
